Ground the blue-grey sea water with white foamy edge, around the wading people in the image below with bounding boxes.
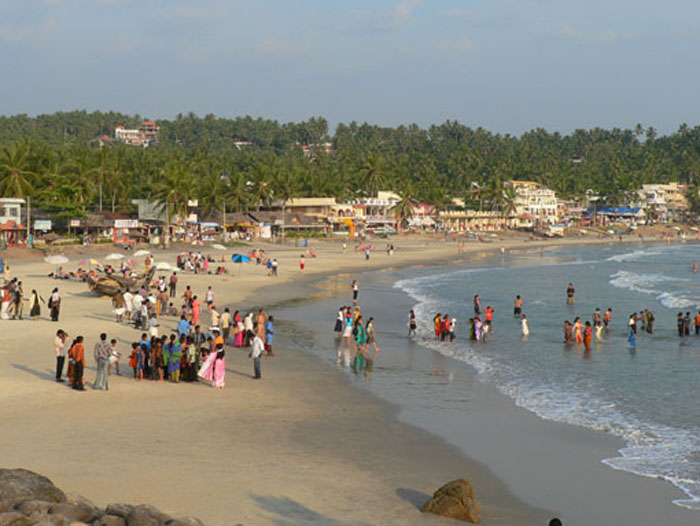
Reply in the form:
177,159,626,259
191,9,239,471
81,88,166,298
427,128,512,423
395,244,700,520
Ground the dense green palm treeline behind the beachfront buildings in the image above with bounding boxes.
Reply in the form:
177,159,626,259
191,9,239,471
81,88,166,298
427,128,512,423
0,111,700,220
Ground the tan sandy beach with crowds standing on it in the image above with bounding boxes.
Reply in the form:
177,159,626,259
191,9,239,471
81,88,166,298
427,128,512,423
0,238,688,525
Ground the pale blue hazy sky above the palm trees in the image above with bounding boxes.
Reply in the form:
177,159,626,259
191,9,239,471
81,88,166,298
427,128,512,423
0,0,700,135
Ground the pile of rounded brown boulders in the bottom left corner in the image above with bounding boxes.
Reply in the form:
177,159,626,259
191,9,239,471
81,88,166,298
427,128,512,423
0,469,204,526
